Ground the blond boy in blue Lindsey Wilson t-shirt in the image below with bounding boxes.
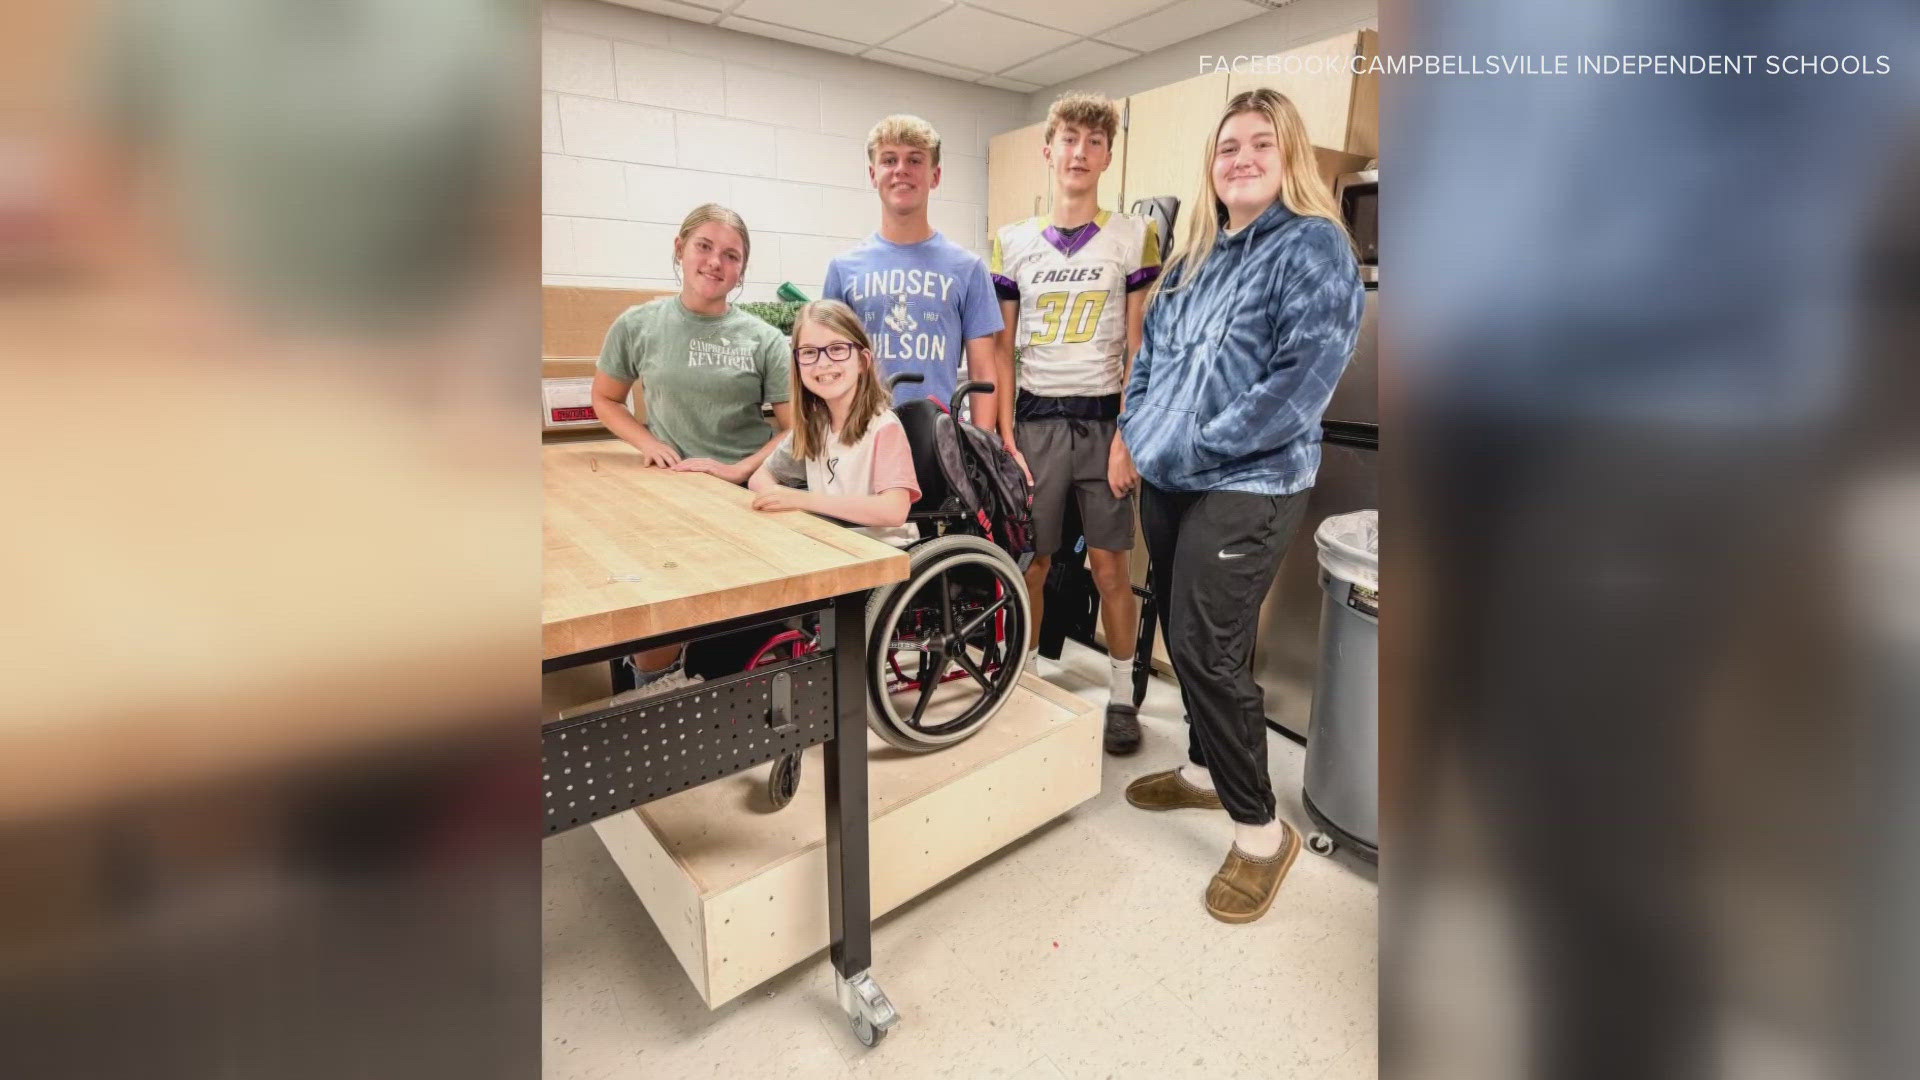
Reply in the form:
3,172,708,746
824,115,1012,424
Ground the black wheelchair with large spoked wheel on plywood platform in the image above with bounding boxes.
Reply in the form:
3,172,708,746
747,373,1033,809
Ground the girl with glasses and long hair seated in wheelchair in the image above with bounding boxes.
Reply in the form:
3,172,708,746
747,300,920,548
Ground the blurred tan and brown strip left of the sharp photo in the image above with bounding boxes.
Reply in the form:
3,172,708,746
0,0,540,1078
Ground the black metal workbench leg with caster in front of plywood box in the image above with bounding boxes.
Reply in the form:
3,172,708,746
822,592,899,1045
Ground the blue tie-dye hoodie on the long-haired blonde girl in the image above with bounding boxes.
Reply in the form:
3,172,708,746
1119,202,1365,496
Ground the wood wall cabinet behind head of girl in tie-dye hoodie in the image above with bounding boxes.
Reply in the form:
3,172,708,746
1227,31,1380,158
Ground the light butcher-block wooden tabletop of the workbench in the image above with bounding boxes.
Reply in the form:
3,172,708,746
541,438,908,659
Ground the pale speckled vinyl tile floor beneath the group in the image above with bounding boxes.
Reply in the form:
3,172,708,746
543,642,1379,1080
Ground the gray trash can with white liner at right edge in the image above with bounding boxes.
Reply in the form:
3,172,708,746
1302,509,1380,861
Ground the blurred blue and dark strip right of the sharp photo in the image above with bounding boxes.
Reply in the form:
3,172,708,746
1380,0,1920,1080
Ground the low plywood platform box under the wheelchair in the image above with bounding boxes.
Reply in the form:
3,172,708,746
593,676,1100,1009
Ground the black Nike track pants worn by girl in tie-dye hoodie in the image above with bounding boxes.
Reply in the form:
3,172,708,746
1140,482,1308,824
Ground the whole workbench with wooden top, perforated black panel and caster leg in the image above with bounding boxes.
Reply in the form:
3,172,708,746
541,440,910,1045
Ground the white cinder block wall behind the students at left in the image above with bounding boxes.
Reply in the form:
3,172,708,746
541,0,1029,300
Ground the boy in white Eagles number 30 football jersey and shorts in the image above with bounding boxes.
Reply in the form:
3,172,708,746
991,94,1160,753
